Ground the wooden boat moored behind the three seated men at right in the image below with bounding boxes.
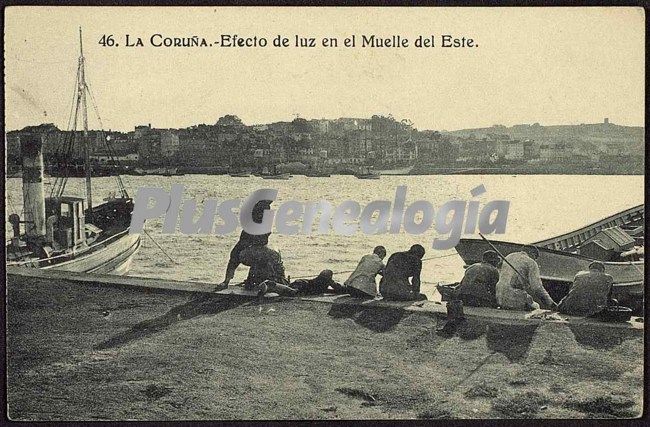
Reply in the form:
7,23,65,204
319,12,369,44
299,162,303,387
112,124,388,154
456,205,645,308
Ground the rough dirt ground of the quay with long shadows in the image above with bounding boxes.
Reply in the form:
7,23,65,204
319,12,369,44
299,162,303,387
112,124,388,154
7,277,643,420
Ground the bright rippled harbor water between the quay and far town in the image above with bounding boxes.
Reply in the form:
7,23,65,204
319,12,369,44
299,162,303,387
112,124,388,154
5,175,644,295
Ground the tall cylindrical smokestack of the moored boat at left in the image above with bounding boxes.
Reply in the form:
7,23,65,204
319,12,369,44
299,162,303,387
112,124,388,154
20,134,45,238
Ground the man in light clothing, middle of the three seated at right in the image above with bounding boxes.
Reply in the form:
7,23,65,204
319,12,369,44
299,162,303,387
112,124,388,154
496,245,557,310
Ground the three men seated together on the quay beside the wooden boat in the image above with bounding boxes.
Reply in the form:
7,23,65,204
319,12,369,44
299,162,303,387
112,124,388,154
456,246,616,316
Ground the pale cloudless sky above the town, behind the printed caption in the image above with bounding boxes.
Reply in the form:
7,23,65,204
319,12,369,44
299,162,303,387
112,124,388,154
4,6,645,131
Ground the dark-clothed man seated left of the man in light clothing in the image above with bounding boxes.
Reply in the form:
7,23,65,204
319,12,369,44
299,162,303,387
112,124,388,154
456,251,501,307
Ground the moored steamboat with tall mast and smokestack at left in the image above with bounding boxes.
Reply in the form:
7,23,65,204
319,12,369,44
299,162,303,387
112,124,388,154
6,28,140,274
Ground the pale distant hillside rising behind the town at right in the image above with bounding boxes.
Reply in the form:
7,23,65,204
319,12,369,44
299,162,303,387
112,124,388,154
445,122,645,153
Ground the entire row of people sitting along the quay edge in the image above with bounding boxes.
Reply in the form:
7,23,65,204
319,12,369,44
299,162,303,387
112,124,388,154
217,200,616,316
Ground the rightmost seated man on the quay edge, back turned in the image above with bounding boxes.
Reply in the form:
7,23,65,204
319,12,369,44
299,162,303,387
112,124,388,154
559,261,616,316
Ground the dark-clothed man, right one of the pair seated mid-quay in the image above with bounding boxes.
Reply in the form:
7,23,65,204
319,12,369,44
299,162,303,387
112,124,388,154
379,245,427,301
